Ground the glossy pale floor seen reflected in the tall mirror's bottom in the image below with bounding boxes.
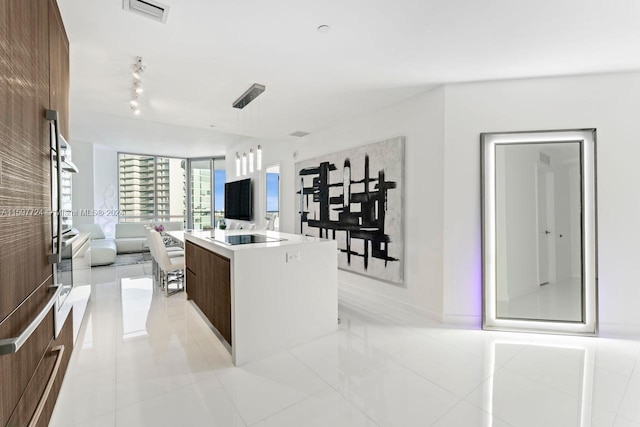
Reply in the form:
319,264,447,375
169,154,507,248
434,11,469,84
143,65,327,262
498,279,582,321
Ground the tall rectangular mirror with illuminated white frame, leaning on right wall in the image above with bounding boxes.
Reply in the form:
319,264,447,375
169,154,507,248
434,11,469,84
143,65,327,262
481,129,598,335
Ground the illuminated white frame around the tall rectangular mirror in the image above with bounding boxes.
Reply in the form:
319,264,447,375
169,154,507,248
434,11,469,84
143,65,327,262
480,129,598,335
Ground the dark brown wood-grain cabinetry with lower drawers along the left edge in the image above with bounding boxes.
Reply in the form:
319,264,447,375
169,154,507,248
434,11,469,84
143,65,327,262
0,0,73,426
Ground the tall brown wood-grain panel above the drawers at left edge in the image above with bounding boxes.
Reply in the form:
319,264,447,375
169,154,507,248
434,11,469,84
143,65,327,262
0,0,53,322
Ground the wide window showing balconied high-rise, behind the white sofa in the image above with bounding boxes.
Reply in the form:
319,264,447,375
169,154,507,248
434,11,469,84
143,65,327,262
118,153,187,227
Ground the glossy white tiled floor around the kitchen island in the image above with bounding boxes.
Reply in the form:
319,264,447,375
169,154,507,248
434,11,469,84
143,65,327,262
51,265,640,427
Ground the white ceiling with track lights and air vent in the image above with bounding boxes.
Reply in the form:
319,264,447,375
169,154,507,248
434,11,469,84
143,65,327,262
58,0,640,151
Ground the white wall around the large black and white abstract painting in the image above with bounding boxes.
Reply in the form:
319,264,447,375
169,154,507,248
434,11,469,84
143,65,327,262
290,88,444,319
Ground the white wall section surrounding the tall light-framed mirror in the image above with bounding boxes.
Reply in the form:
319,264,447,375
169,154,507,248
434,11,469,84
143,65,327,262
444,73,640,334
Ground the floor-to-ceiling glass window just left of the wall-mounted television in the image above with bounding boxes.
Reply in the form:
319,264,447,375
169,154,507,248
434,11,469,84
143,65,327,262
189,158,227,230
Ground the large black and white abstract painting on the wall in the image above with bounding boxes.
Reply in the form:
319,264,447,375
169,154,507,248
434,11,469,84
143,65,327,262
296,137,404,284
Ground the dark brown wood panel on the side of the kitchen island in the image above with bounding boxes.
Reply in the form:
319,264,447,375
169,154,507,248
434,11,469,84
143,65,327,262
185,242,233,345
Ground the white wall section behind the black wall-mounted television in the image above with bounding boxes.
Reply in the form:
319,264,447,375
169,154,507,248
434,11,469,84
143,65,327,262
225,138,295,233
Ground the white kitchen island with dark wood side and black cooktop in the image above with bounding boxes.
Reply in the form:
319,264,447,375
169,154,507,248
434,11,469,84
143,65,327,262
179,230,338,366
